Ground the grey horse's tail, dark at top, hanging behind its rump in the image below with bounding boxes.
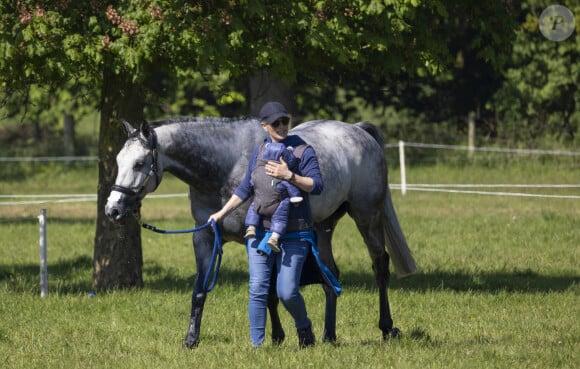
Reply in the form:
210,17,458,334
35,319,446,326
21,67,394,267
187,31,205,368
355,122,417,277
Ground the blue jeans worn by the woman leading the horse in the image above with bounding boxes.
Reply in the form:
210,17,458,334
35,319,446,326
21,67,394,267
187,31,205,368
247,238,311,346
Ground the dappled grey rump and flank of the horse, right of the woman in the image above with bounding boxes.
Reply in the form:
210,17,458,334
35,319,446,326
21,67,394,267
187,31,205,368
291,120,386,221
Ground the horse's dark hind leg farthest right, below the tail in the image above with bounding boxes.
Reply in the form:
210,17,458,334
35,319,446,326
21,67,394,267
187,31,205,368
351,209,398,339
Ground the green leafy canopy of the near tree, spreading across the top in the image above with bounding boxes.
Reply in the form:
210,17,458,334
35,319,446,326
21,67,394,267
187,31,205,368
0,0,517,134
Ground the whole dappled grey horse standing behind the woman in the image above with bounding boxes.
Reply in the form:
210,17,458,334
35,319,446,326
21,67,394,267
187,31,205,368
105,117,416,348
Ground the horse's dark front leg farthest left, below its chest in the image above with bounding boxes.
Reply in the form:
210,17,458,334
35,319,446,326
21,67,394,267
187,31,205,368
184,229,213,349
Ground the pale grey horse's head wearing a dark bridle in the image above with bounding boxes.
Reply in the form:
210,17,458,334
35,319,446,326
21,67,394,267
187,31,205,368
105,121,162,221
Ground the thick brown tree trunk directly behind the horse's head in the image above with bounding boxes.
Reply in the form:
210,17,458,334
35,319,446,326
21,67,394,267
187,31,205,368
93,71,144,290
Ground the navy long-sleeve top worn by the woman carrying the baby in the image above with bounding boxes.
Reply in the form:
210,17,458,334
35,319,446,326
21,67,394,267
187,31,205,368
234,135,324,222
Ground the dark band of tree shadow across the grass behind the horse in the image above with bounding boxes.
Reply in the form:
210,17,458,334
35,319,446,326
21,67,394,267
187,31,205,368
0,256,580,294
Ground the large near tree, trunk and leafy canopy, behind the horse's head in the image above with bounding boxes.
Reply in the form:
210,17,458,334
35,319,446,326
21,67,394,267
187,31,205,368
0,0,512,288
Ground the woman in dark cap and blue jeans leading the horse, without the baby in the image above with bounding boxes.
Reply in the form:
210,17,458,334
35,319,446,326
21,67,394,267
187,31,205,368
209,102,323,348
